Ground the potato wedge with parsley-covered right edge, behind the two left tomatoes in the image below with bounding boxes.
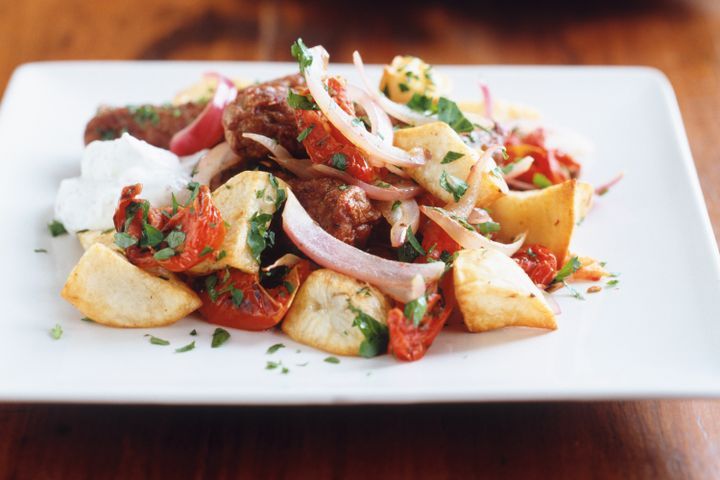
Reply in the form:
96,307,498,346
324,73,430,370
190,171,288,275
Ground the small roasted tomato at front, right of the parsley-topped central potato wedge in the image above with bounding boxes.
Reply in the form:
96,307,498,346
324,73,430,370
387,293,452,362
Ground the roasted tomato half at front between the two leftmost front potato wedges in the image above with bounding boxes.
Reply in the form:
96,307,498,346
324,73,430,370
199,262,307,330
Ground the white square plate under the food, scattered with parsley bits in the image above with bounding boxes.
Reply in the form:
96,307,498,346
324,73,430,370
0,62,720,404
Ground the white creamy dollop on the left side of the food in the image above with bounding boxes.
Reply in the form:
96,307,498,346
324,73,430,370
55,133,194,232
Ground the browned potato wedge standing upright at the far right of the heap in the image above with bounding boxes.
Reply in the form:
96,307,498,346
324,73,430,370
490,180,592,262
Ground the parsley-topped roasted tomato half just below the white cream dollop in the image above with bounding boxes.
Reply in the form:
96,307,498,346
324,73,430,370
113,183,225,272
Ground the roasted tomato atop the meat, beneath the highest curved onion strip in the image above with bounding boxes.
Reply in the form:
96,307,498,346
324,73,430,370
295,77,377,183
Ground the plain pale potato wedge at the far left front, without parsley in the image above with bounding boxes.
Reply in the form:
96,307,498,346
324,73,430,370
60,243,201,328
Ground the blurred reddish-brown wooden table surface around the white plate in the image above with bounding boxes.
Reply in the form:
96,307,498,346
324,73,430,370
0,0,720,479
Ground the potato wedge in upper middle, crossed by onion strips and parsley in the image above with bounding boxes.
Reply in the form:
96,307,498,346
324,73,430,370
394,122,508,207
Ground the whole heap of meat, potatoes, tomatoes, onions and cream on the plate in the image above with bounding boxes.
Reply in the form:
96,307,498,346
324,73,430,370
54,40,620,360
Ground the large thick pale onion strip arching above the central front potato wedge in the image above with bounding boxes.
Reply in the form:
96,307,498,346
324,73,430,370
282,192,445,303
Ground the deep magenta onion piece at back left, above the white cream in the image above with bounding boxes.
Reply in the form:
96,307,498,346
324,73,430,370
170,74,237,156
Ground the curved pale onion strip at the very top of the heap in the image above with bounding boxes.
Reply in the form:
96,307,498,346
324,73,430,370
304,46,425,167
